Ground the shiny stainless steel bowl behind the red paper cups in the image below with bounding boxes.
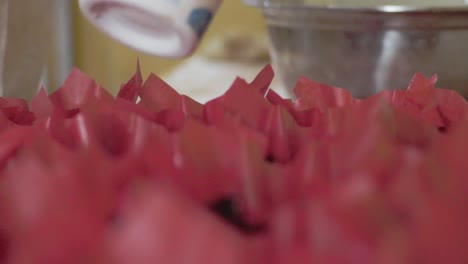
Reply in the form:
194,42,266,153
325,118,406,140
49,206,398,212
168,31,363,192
244,0,468,97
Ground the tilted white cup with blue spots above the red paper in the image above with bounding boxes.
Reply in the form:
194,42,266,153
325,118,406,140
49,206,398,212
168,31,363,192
79,0,222,58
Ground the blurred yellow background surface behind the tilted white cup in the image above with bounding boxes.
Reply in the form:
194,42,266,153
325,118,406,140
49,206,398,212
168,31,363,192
74,0,266,92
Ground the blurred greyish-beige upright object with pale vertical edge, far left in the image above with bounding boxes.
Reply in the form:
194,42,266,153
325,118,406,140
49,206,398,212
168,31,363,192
0,0,73,99
